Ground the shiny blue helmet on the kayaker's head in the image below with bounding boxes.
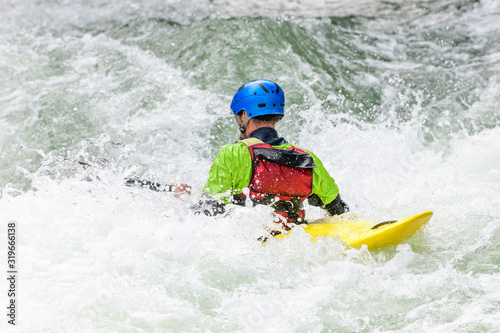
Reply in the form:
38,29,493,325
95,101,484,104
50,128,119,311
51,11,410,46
231,80,285,118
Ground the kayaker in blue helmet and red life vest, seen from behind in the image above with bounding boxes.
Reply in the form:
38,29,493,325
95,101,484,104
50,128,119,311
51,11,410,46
197,80,349,229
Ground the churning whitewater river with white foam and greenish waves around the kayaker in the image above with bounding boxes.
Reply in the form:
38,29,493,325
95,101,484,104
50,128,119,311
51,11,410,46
0,0,500,332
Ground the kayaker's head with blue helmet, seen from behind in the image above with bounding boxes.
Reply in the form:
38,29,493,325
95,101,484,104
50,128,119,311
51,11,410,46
231,80,285,138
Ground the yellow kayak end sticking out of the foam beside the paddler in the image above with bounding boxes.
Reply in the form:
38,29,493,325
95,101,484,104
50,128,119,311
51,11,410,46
276,211,432,249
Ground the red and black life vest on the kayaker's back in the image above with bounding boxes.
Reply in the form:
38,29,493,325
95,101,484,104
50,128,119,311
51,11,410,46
235,138,316,230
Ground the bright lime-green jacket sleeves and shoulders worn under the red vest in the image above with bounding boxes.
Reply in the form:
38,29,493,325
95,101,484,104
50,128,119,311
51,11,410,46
203,137,339,205
